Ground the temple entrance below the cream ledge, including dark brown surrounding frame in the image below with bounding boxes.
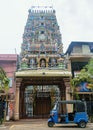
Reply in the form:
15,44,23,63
16,73,70,119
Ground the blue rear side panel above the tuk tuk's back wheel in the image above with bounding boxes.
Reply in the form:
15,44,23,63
74,112,88,123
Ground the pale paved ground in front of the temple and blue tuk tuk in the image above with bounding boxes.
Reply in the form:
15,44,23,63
0,119,93,130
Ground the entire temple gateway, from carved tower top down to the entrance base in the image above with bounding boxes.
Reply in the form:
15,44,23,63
14,6,71,120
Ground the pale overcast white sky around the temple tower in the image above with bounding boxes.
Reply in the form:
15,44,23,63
0,0,93,54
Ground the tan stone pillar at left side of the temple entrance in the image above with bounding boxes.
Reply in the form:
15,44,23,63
14,86,20,120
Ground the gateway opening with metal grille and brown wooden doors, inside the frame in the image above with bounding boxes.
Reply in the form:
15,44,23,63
20,85,60,118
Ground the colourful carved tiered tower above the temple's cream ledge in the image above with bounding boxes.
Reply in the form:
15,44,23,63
21,6,63,68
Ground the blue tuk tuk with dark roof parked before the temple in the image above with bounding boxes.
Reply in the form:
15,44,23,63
48,100,88,128
